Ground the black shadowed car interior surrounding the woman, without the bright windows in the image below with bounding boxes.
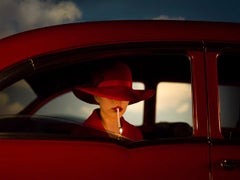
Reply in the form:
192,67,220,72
0,43,193,140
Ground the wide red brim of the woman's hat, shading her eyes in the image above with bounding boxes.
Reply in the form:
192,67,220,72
73,86,155,104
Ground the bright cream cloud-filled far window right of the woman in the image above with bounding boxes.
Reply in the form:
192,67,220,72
156,82,193,126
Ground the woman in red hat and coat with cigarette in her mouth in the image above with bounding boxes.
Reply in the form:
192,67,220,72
73,62,154,141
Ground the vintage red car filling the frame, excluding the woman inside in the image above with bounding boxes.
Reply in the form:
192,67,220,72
0,20,240,180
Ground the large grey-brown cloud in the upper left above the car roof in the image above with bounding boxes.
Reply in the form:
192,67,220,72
0,0,82,38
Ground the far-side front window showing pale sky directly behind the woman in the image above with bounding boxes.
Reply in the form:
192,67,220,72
35,82,144,126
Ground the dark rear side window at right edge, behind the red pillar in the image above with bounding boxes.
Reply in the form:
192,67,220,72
217,54,240,139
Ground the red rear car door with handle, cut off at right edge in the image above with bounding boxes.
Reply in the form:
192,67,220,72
206,44,240,179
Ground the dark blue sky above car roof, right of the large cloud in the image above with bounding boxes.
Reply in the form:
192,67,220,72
74,0,240,22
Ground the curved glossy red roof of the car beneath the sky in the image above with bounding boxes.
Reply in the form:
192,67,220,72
0,20,240,70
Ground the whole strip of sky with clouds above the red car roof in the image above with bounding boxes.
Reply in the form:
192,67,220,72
0,0,240,38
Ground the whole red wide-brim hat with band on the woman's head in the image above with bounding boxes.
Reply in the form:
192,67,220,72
73,62,155,104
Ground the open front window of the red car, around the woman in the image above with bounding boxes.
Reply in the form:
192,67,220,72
0,42,194,140
